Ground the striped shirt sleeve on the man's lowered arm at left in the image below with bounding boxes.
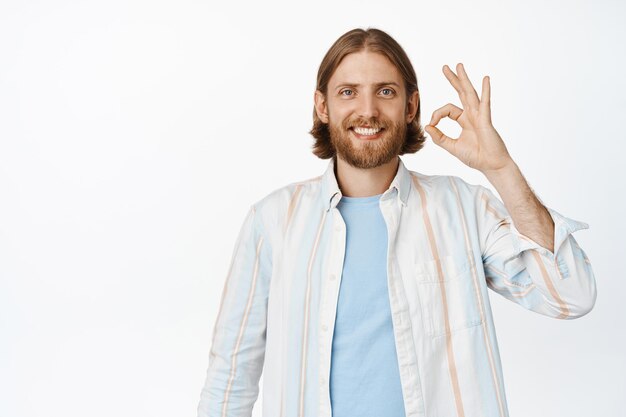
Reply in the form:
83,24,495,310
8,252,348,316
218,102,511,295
198,205,272,417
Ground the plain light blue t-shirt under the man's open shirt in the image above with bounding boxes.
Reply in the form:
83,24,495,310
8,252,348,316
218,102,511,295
330,194,405,417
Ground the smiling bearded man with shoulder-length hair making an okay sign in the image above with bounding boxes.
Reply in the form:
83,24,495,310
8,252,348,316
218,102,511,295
198,29,596,417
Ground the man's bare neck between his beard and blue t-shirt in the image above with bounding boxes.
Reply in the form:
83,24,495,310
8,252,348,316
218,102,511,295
335,157,400,197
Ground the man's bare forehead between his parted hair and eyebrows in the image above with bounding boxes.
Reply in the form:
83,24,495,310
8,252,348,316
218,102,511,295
329,50,402,88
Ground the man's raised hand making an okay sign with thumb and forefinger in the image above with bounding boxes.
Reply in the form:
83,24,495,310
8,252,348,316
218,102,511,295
425,63,513,174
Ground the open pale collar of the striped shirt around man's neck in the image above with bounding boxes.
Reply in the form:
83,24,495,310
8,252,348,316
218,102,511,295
322,157,411,211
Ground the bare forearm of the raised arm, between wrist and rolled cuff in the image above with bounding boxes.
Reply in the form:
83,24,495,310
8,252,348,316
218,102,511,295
483,160,554,253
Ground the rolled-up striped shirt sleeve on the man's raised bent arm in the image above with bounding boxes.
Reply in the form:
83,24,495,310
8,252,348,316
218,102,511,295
476,186,596,319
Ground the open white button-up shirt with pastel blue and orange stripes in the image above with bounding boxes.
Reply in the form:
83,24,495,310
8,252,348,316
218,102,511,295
198,159,596,417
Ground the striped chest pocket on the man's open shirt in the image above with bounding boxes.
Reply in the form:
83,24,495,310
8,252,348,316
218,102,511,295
415,256,482,337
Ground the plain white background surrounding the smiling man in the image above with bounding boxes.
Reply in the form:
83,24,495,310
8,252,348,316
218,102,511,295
0,0,626,417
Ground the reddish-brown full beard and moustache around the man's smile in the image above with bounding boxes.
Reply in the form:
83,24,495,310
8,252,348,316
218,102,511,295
328,114,407,169
